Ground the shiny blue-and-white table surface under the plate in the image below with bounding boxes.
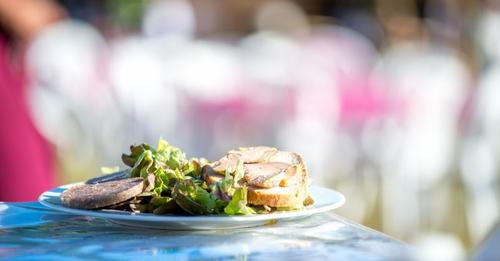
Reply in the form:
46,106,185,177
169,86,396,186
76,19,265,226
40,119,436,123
0,202,412,260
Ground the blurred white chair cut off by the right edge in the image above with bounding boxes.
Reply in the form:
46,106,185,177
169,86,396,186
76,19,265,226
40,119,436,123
460,62,500,243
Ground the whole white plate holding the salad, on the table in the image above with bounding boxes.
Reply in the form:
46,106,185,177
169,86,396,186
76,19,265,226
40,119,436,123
38,184,345,230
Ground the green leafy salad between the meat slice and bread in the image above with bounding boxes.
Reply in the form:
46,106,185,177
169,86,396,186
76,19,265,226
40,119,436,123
109,139,257,215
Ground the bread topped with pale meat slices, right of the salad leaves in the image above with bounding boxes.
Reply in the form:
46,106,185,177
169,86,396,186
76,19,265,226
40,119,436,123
204,147,309,208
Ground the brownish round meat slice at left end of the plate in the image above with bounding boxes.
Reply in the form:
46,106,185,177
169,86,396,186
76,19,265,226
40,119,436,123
61,178,144,209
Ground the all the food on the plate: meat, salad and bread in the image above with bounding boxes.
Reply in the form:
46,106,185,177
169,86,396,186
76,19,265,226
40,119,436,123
61,139,313,215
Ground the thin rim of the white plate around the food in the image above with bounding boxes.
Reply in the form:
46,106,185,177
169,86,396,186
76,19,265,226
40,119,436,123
38,182,346,222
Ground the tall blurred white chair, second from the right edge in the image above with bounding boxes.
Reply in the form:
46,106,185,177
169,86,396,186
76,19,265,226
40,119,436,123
377,43,469,236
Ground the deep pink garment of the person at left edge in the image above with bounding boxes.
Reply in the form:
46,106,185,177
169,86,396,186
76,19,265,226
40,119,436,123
0,36,54,201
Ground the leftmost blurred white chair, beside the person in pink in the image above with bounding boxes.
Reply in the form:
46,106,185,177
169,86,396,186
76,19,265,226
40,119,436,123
26,20,115,182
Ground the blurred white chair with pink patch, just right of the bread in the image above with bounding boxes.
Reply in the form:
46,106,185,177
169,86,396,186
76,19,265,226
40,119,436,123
279,25,379,221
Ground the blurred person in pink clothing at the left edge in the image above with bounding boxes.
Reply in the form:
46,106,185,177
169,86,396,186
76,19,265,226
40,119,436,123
0,0,63,201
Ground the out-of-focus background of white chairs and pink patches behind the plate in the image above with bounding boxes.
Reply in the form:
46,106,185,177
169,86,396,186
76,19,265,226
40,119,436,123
0,0,500,260
